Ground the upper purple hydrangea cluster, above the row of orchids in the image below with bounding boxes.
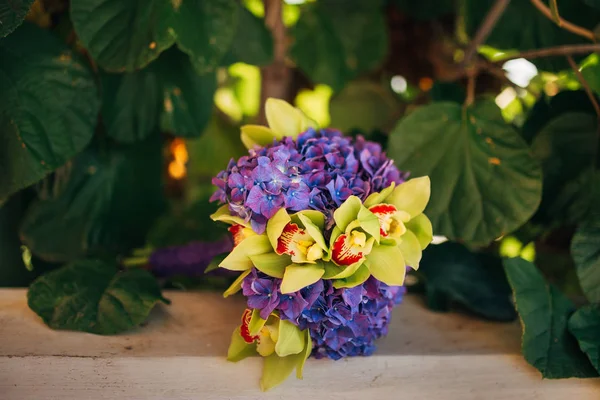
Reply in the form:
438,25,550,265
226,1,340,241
211,128,408,234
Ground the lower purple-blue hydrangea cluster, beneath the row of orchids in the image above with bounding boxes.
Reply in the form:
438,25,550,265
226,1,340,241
242,269,405,360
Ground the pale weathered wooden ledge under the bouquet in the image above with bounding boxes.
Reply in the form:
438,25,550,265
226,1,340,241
0,289,600,400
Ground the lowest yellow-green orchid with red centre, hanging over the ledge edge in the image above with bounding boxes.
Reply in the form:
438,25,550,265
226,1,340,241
227,309,312,391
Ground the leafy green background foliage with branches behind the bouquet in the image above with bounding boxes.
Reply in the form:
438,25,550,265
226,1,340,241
0,0,600,378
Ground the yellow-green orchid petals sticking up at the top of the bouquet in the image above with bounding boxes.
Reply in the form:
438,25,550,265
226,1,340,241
241,98,318,149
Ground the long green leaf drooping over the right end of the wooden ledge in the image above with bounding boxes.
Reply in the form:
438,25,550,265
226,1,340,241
504,258,598,379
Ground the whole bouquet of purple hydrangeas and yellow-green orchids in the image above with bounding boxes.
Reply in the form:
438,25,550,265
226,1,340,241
212,99,432,390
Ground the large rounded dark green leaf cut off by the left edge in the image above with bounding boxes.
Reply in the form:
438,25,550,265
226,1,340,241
0,23,100,199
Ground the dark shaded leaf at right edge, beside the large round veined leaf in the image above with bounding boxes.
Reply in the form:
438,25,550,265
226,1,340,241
531,112,598,225
